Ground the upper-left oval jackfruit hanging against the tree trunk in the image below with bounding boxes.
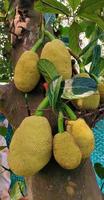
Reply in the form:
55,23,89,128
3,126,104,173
14,51,40,92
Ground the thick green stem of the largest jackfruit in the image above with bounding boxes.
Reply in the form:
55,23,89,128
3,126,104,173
34,96,49,116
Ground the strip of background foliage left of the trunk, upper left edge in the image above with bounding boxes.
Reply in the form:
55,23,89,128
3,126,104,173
0,0,13,82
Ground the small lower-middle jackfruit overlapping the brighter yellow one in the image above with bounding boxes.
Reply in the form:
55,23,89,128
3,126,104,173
53,132,82,169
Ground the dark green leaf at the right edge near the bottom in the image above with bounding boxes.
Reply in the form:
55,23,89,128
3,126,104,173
94,163,104,179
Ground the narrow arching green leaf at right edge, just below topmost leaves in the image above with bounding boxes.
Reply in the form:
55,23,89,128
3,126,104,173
80,12,104,30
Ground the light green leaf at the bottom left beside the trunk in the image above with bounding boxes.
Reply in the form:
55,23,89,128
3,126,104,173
10,181,26,200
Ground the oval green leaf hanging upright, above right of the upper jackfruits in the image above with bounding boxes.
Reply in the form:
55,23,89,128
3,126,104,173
69,22,82,55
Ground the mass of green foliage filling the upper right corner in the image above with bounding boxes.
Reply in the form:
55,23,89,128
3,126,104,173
34,0,104,76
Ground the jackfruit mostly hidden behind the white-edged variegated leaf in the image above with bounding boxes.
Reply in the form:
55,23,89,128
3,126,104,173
72,73,100,110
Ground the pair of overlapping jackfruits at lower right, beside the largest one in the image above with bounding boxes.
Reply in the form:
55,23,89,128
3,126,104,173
53,118,94,169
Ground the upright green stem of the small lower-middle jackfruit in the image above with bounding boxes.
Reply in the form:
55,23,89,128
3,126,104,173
58,111,64,133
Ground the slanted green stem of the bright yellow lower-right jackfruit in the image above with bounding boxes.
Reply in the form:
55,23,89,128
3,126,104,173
63,103,77,120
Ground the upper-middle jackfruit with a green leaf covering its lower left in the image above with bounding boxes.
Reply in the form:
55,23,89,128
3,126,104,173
41,39,72,80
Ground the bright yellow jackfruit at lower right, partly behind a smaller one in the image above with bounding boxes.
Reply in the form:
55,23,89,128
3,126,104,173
67,118,94,159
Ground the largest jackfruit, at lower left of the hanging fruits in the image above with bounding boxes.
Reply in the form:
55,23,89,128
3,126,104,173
8,116,52,176
